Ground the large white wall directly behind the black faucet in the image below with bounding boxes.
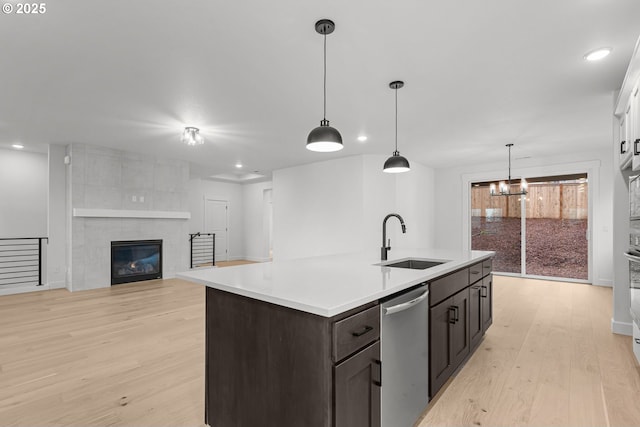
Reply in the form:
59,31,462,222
273,155,434,260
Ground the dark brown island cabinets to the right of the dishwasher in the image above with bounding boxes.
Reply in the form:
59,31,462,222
429,259,493,398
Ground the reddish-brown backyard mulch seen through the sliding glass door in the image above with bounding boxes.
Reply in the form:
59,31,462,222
471,216,589,280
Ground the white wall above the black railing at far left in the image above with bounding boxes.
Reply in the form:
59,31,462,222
0,148,49,237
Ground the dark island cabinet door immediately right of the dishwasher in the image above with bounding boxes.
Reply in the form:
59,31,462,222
429,297,455,398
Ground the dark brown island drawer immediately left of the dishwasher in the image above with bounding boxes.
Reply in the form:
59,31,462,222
333,305,380,362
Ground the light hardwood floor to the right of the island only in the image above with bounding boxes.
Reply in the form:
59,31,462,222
418,276,640,427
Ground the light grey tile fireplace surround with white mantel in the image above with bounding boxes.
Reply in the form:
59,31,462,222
66,144,190,291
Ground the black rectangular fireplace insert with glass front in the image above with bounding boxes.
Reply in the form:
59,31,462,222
111,240,162,285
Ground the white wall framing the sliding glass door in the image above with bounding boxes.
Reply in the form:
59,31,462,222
435,147,613,286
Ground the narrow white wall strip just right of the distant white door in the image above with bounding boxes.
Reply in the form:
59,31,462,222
242,181,273,261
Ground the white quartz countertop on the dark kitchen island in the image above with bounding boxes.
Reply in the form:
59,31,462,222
177,249,494,317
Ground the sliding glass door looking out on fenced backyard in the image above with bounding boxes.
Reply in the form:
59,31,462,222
471,174,589,281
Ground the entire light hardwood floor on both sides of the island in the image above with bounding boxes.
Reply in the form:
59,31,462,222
0,277,640,427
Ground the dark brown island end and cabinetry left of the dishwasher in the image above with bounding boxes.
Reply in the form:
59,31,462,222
205,288,381,427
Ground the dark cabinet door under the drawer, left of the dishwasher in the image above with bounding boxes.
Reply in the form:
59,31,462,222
335,341,382,427
